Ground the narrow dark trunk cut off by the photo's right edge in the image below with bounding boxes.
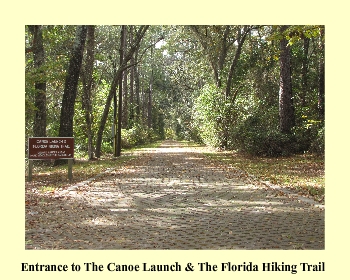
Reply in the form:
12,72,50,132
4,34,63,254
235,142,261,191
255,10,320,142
318,26,325,121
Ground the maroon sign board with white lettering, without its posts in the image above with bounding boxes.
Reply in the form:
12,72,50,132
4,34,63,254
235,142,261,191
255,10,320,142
28,137,74,160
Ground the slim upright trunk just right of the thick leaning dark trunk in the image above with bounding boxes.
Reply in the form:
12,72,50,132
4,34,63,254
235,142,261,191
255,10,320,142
82,25,95,160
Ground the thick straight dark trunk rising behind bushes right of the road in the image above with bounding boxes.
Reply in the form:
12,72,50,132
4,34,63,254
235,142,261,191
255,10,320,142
279,25,295,134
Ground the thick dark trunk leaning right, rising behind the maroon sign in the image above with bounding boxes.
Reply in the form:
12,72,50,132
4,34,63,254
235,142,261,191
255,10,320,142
59,25,87,137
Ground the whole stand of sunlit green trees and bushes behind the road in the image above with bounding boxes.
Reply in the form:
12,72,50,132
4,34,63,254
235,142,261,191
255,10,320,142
25,25,325,159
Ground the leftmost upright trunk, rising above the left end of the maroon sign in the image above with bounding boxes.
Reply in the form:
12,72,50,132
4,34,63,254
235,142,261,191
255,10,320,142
28,25,46,137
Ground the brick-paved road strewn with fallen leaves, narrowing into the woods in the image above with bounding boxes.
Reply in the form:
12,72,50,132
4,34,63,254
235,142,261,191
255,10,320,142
26,141,325,249
